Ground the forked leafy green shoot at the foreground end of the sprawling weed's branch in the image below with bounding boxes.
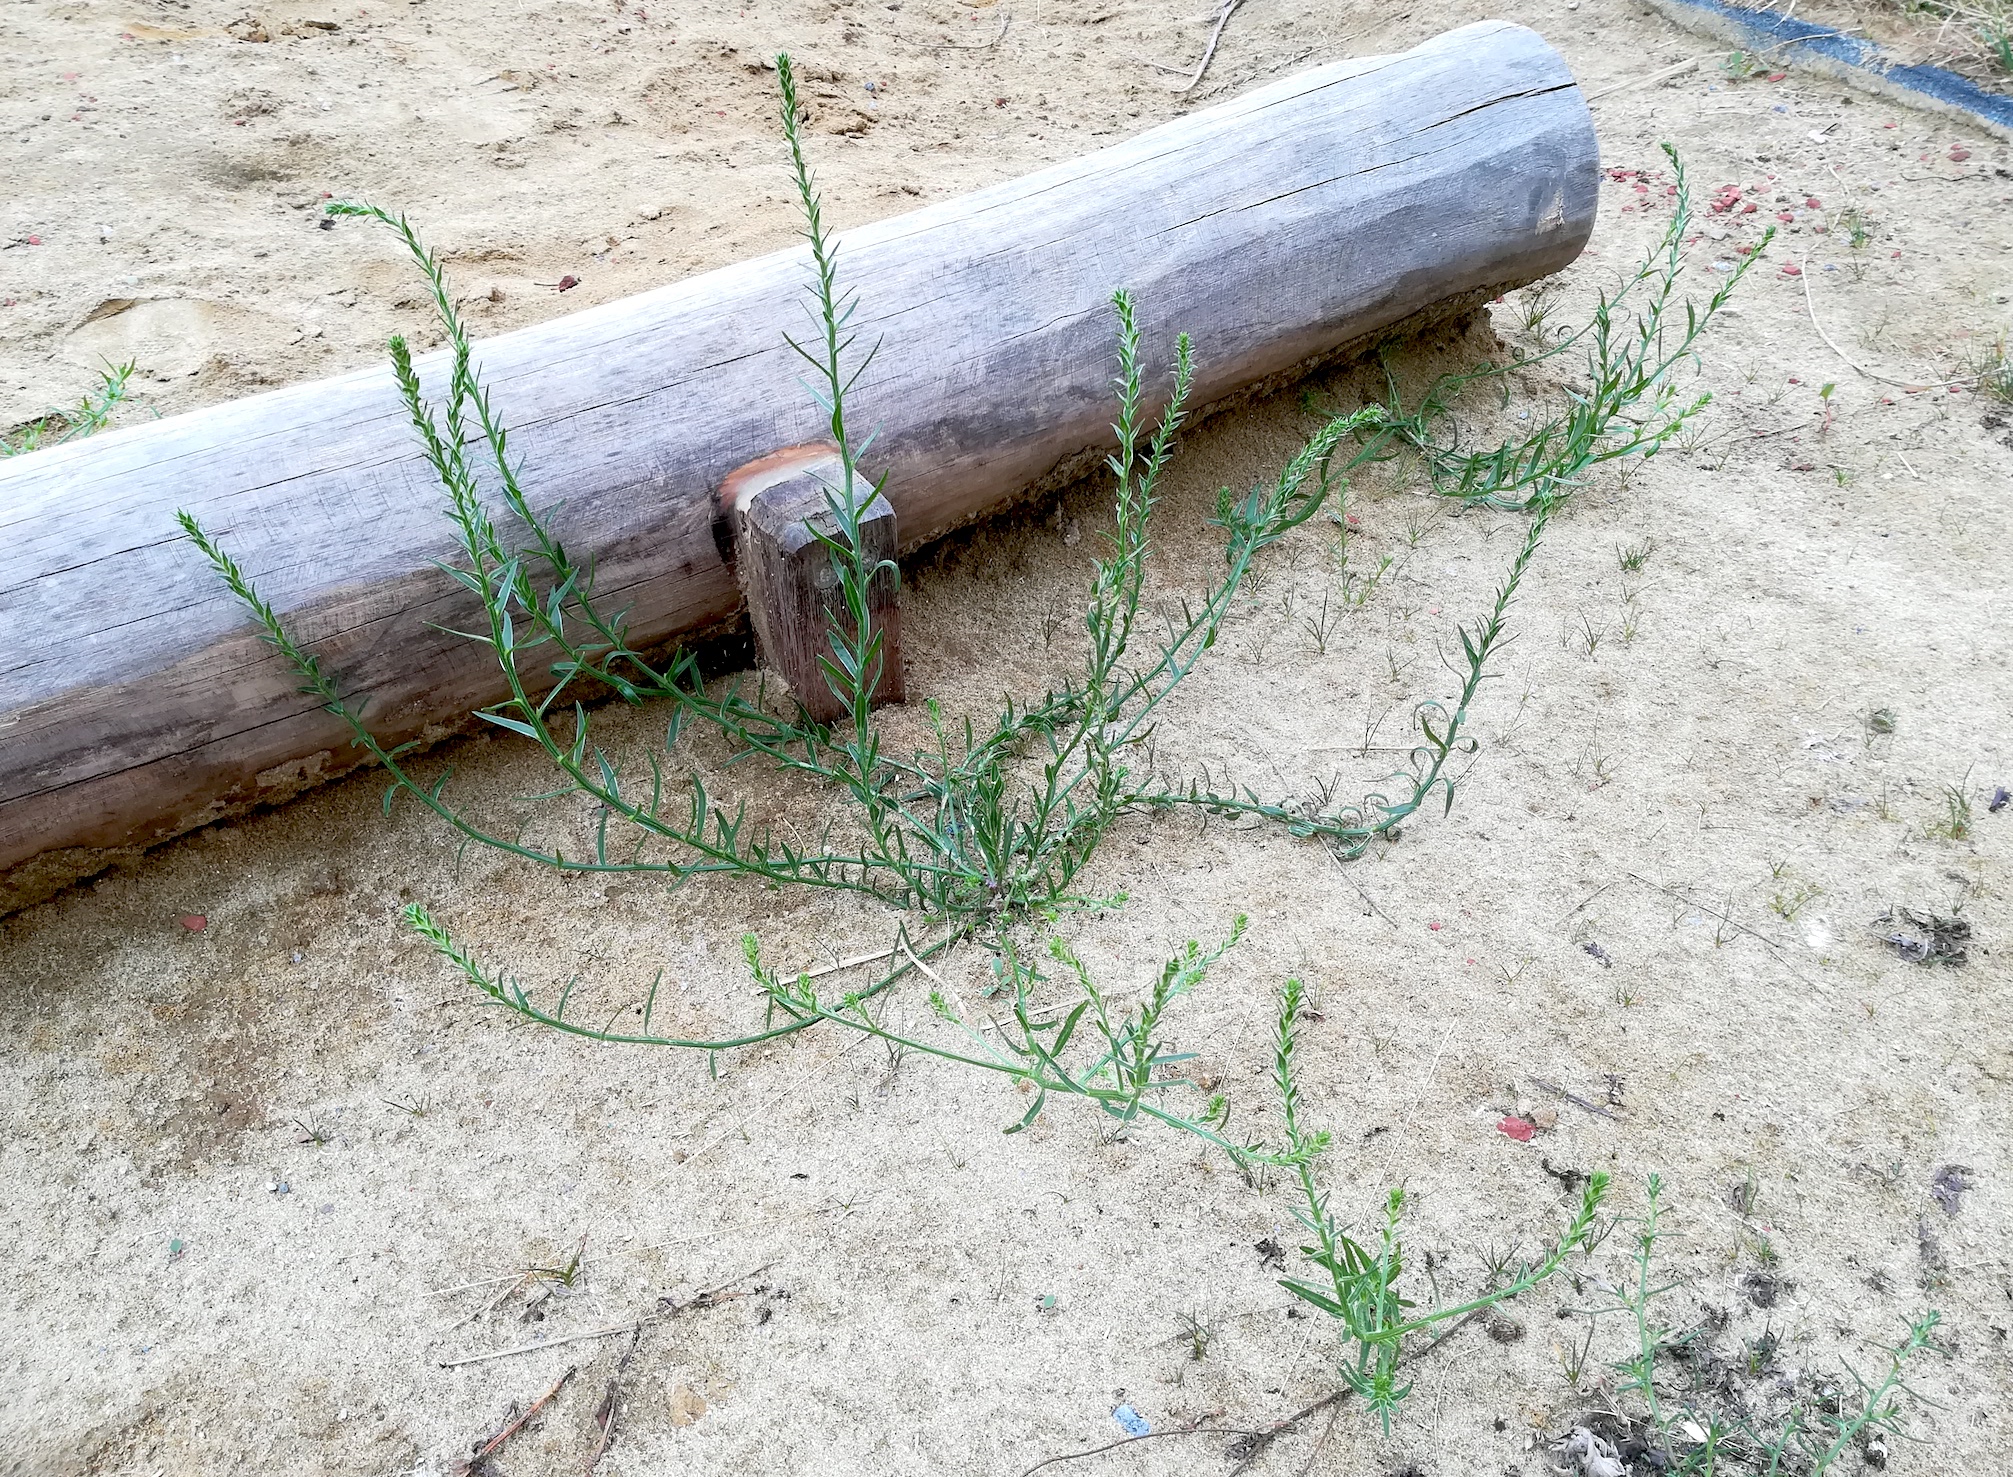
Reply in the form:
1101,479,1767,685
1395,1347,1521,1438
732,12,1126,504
1272,980,1608,1431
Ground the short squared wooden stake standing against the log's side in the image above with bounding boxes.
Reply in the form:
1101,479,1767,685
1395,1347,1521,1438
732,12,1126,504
721,445,904,722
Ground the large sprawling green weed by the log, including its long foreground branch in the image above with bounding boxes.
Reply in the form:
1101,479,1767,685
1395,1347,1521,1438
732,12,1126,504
181,56,1779,1421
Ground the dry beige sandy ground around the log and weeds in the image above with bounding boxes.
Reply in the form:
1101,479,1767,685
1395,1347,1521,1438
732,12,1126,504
0,0,2013,1477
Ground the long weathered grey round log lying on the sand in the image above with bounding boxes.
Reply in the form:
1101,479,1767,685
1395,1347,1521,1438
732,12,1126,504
0,22,1598,910
